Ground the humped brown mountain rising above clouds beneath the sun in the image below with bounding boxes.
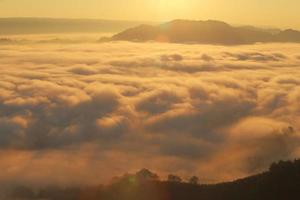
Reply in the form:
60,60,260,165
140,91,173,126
111,20,300,45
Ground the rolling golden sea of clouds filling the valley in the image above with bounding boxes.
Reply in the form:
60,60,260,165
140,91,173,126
0,40,300,187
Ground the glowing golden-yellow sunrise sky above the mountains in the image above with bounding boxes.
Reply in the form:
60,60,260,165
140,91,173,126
0,0,300,29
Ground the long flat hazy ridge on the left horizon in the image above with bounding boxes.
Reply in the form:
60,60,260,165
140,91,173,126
0,18,152,35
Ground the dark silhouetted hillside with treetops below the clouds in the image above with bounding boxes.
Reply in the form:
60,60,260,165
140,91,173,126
11,160,300,200
